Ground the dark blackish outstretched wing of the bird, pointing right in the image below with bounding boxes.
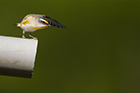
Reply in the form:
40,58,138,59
43,15,66,28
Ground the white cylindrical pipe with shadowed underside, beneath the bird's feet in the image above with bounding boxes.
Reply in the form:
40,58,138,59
0,36,38,78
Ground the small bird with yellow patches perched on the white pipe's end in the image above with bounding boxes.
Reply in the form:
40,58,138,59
14,14,66,40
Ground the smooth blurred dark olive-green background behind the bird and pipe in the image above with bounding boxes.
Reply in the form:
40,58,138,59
0,0,140,93
